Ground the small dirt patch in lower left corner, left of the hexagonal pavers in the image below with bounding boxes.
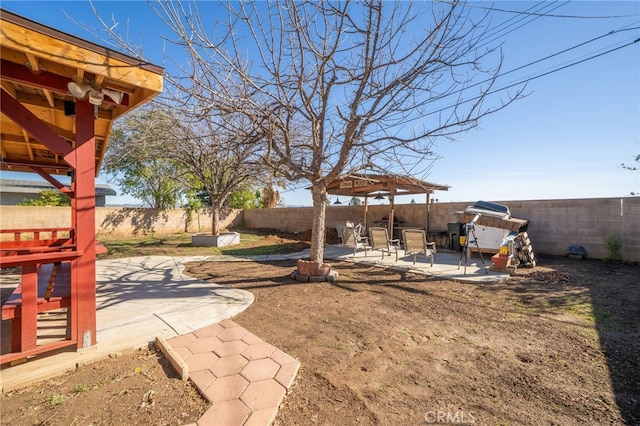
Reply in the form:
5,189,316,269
0,348,208,426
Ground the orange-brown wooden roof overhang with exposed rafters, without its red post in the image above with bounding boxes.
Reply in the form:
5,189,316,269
0,10,163,174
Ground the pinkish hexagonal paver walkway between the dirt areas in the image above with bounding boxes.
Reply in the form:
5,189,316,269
162,320,300,426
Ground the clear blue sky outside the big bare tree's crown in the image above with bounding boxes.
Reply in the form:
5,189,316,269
2,0,640,205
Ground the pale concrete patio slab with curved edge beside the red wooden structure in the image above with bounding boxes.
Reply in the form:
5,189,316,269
0,256,253,392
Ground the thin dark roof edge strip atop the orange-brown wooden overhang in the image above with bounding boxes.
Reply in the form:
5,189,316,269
0,8,164,75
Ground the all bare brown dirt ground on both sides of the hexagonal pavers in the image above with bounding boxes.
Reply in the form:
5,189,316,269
0,251,640,425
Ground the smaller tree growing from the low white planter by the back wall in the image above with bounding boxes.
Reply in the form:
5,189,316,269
103,101,264,235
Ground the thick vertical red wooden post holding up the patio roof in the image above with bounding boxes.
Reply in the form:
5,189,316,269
71,99,96,349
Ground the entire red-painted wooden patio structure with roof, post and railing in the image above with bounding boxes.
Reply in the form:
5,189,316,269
0,10,163,364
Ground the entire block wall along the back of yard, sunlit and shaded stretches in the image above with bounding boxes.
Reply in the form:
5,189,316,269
0,197,640,262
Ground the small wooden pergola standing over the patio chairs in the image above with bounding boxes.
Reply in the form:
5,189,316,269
327,174,450,235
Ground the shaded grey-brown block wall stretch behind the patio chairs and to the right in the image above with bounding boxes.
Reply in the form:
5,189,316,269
244,197,640,262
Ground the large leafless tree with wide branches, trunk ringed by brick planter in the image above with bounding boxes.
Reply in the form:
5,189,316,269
99,0,520,261
